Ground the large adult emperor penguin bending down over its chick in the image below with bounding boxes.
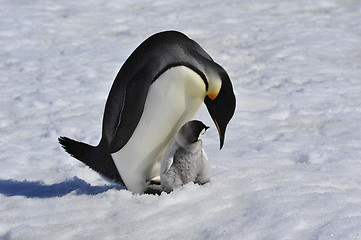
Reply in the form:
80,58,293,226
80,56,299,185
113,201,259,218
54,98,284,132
59,31,236,193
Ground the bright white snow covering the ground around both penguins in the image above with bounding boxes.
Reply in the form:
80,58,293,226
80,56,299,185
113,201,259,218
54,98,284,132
0,0,361,239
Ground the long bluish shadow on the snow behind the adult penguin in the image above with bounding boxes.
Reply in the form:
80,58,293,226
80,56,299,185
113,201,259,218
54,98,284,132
0,177,125,198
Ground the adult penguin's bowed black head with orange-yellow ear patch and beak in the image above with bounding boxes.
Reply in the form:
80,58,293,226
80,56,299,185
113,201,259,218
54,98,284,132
204,62,236,149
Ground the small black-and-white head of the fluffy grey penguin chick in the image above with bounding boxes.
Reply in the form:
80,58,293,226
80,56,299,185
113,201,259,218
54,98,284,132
176,120,209,147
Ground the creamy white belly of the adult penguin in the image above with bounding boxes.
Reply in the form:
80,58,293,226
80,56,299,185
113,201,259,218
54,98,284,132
112,66,206,193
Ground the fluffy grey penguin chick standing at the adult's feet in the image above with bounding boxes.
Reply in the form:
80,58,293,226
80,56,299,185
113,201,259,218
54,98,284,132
160,120,210,193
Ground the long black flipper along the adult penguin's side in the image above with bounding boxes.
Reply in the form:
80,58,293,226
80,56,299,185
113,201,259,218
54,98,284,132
103,44,162,153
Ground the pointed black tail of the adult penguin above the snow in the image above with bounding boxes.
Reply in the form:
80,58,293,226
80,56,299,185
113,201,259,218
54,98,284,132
58,137,125,186
